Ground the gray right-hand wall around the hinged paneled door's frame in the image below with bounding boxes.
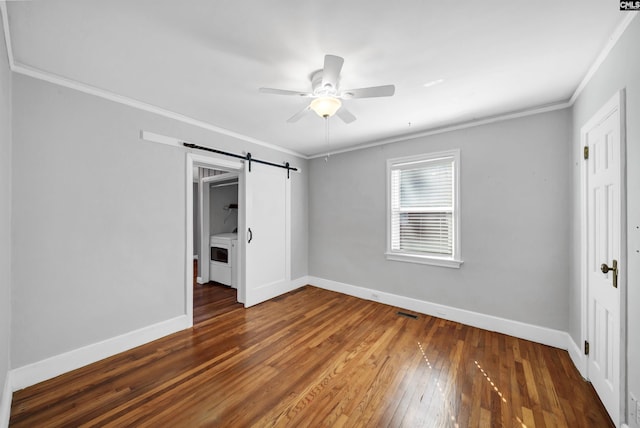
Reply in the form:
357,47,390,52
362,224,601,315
569,17,640,418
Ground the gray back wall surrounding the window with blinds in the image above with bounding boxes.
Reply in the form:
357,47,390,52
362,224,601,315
309,109,571,330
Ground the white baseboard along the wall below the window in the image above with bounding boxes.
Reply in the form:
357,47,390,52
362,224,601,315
309,276,568,349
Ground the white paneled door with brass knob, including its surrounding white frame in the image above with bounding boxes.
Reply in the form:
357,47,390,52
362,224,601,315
580,91,627,426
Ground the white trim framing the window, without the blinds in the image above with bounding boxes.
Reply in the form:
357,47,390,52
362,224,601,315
385,149,463,269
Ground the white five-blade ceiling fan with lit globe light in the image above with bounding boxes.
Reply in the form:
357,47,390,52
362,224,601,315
260,55,396,123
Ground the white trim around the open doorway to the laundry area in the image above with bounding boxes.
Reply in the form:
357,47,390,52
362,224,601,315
184,152,244,328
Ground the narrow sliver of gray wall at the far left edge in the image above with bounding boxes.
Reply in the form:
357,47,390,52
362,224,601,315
0,12,11,408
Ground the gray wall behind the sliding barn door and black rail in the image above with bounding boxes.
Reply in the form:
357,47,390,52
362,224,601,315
11,75,307,368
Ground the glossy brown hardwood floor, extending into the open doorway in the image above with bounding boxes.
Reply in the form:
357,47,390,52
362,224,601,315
10,286,613,427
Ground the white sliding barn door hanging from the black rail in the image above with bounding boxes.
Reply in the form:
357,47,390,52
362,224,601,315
243,163,291,307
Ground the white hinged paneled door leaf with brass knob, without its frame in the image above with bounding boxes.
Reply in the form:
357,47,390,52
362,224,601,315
586,93,622,426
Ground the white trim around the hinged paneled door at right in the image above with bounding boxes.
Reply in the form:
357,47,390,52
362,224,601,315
578,89,628,421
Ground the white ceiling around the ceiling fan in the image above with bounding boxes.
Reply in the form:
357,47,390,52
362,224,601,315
2,0,625,155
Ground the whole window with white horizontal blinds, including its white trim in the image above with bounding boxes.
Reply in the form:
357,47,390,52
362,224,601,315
386,150,462,268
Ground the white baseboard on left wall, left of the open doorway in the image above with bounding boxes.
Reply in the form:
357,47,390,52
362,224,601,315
10,315,189,392
